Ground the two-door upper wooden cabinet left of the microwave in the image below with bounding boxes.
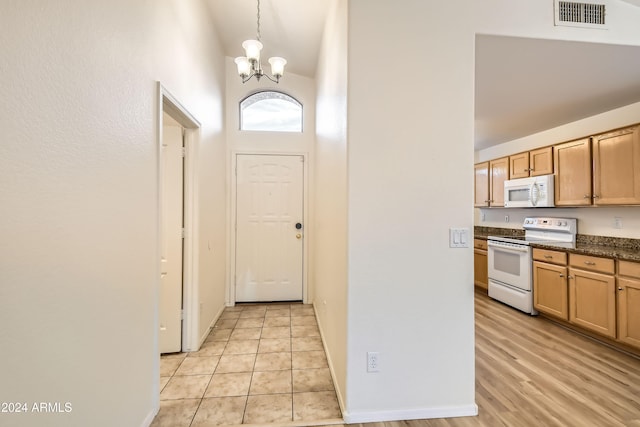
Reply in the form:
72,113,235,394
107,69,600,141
473,157,509,208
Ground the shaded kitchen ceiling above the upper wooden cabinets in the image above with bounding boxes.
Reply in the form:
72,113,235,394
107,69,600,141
475,36,640,149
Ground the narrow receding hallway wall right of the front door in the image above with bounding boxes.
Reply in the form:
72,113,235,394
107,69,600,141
311,0,348,407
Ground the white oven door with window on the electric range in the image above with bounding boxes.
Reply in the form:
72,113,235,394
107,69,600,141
487,240,531,291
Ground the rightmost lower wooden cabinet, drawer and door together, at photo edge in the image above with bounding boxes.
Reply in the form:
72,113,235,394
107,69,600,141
618,261,640,348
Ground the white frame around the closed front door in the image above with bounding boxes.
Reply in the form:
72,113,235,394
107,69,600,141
225,150,312,307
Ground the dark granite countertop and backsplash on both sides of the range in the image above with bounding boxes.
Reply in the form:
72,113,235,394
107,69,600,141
474,227,640,262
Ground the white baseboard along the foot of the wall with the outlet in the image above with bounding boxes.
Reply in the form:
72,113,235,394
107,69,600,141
342,403,478,424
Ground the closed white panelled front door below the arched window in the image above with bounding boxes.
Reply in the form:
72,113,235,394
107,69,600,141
235,154,304,302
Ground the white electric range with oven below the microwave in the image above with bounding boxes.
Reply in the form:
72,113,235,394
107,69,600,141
487,217,577,315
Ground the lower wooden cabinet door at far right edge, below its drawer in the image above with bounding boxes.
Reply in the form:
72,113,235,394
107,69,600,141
618,278,640,348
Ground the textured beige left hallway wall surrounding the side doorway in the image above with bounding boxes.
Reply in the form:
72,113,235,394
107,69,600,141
0,0,225,427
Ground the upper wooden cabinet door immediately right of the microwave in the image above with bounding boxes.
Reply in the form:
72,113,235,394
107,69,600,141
553,138,591,206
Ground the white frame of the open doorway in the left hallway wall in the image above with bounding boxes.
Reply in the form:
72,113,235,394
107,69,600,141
154,81,201,355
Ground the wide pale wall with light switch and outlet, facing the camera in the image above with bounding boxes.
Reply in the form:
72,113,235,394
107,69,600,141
346,0,476,422
